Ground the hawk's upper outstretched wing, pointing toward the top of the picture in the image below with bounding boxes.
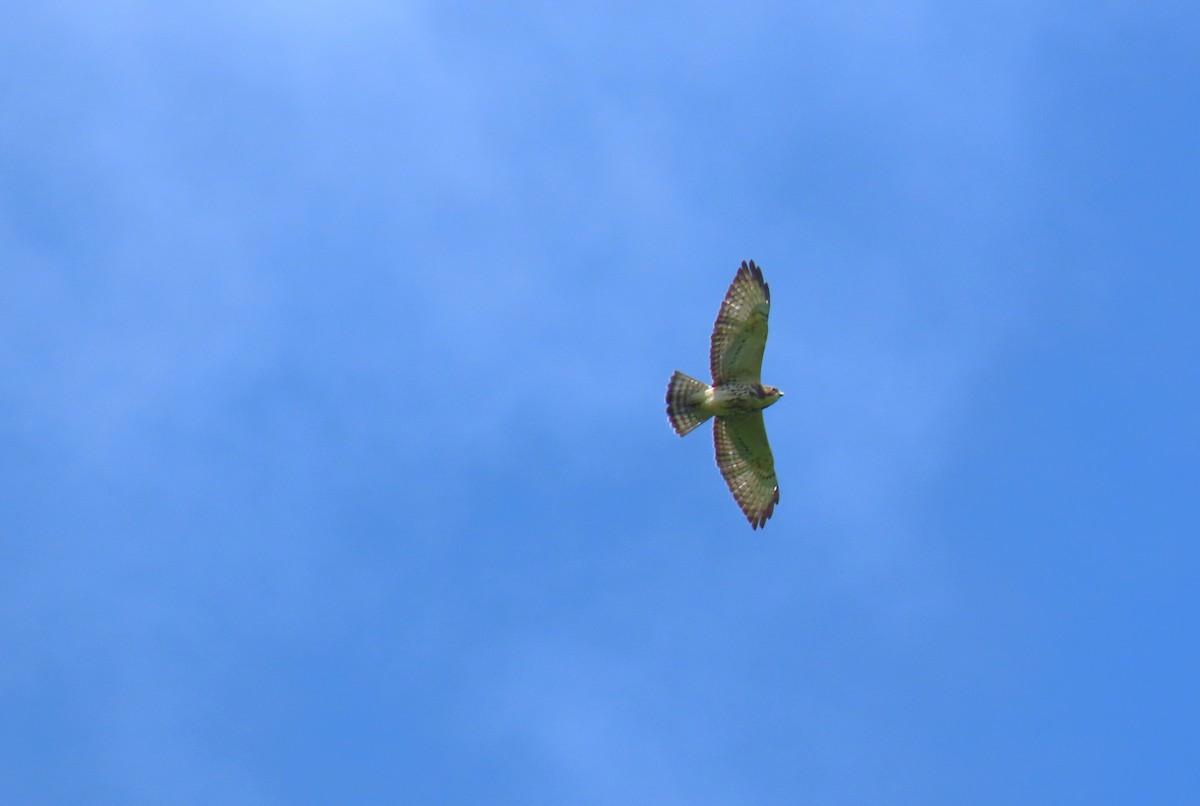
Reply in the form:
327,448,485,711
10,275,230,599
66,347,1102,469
709,260,770,386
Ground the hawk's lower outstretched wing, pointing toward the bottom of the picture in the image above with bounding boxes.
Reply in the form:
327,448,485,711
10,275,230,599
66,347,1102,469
713,411,779,529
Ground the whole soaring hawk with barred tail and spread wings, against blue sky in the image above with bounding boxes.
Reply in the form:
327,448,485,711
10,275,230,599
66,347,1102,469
667,260,784,529
